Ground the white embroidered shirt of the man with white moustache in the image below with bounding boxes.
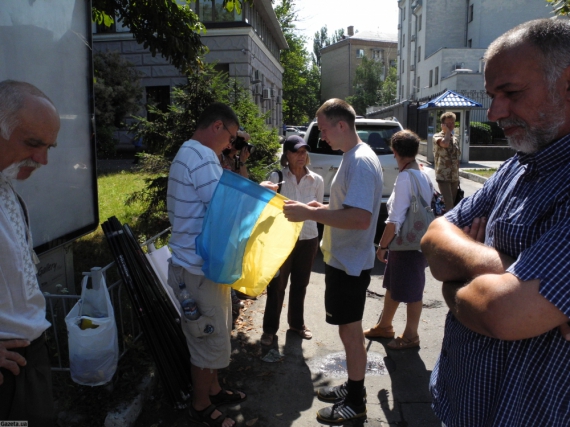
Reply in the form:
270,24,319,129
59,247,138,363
0,172,51,341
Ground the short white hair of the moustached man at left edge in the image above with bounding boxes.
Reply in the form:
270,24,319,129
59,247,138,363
0,80,55,139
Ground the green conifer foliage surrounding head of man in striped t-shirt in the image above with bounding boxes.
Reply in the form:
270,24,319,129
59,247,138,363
129,64,279,235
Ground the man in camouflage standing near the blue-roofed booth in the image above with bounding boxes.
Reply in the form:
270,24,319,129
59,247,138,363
433,112,461,211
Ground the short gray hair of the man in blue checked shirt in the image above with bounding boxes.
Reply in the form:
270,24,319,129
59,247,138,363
483,19,570,85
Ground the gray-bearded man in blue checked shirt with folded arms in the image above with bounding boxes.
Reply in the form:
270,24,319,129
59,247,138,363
422,19,570,427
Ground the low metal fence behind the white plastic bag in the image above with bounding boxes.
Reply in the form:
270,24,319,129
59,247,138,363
44,229,170,371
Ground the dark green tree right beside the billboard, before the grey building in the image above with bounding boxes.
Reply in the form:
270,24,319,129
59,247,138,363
93,52,143,158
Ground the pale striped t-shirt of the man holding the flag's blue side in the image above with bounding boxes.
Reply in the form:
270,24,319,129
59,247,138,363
166,139,222,276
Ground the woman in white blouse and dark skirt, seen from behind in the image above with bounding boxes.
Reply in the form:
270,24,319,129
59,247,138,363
364,130,433,350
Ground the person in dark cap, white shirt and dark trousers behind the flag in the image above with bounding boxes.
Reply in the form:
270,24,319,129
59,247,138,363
260,135,325,346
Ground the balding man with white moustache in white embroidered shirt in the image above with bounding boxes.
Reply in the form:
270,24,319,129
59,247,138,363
0,80,59,426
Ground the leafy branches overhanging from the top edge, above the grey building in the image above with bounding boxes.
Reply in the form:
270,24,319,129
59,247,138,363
92,0,253,72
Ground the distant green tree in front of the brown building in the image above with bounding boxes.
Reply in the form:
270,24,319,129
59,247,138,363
346,56,384,116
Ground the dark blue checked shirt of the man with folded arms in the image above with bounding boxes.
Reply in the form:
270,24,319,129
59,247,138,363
430,135,570,427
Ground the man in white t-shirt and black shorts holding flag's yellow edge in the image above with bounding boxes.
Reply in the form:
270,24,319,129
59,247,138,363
284,99,382,423
